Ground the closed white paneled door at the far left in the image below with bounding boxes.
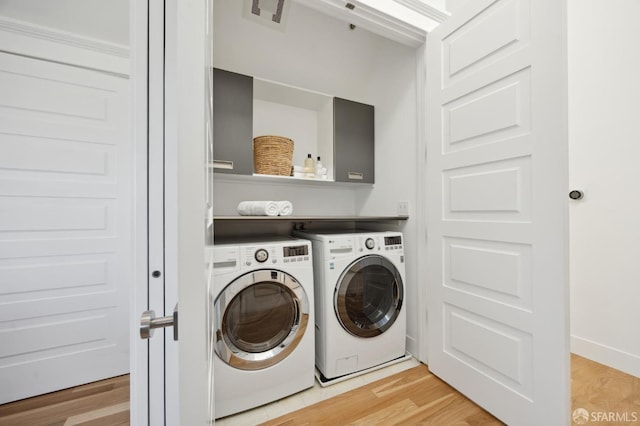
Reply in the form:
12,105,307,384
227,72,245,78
0,53,132,404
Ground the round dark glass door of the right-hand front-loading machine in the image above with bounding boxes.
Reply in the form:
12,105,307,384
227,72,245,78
334,255,404,337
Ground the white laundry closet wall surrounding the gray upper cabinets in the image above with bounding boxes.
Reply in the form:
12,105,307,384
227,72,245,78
214,0,418,354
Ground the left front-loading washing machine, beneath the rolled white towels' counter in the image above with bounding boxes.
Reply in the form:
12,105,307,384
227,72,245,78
209,238,315,418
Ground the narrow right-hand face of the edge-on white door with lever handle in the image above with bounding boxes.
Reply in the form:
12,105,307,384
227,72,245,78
169,0,213,425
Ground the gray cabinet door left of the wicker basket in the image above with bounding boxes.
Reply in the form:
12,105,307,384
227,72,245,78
213,68,253,175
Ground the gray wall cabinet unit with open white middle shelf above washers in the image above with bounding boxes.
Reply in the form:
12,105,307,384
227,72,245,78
213,68,375,184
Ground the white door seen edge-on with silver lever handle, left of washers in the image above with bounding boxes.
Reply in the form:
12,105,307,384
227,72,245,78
131,0,213,425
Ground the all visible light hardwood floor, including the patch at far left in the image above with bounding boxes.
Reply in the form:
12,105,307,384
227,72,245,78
0,355,640,426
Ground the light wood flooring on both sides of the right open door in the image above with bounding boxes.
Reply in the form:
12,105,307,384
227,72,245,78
263,354,640,426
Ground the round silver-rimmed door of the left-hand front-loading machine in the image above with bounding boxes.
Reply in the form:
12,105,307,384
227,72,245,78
214,269,309,370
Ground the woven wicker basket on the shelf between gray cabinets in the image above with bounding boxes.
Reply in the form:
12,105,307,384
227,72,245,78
253,136,293,176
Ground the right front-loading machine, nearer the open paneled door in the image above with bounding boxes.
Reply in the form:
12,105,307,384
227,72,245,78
295,231,406,380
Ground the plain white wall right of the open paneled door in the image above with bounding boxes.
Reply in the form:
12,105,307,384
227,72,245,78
568,0,640,376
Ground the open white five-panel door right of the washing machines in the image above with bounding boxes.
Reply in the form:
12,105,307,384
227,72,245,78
426,0,570,425
